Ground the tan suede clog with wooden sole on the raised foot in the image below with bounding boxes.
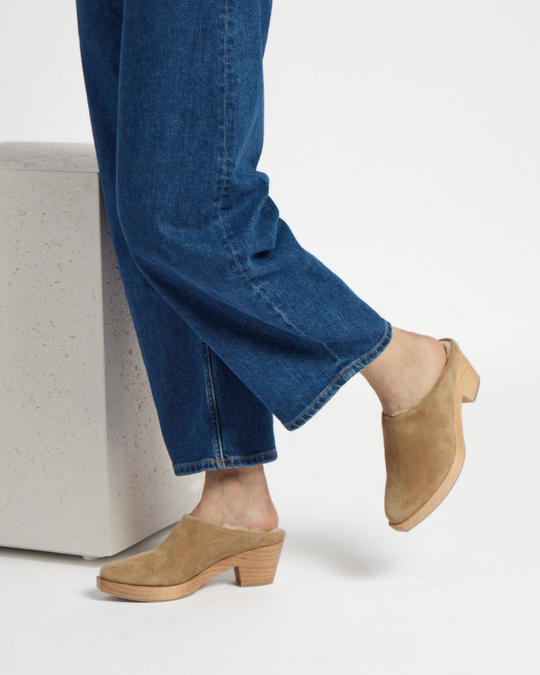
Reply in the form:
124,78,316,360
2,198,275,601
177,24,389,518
382,338,480,532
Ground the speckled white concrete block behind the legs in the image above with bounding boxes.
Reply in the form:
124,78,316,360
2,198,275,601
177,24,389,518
0,143,204,557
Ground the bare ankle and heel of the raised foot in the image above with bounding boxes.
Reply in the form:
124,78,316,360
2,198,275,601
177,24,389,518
361,327,447,415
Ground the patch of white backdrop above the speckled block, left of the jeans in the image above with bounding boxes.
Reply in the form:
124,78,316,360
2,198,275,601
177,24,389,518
0,0,92,143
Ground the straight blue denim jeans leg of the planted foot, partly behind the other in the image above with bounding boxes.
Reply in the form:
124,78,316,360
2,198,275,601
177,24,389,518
77,0,277,475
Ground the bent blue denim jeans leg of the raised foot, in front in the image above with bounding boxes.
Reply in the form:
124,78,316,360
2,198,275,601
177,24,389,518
79,0,392,430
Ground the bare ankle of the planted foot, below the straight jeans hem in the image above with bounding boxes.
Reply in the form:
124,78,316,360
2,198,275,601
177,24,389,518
191,464,278,532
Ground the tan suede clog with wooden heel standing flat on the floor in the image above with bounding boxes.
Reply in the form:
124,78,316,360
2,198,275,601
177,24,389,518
96,514,285,602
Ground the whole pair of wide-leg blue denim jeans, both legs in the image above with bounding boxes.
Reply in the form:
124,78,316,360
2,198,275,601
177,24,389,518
77,0,392,475
